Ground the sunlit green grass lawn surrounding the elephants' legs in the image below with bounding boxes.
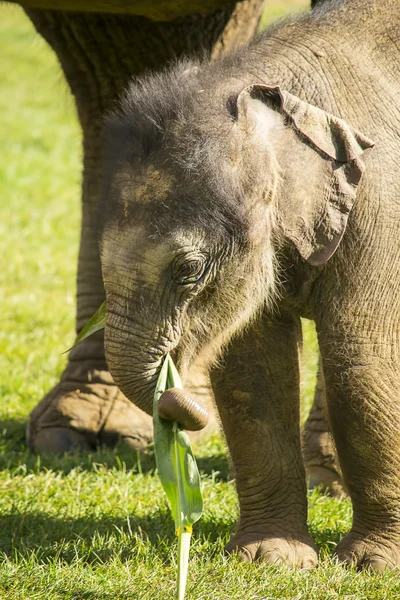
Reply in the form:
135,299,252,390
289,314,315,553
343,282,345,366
0,0,400,600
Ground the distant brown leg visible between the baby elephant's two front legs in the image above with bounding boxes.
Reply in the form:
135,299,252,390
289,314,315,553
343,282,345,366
302,359,346,497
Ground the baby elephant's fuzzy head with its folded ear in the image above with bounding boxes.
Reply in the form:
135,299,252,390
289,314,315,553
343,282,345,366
100,66,373,422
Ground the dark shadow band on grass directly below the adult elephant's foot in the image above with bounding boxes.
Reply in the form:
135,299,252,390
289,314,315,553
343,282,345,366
0,419,229,481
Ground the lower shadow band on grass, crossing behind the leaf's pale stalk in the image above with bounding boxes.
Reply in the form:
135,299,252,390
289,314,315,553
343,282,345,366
0,508,233,564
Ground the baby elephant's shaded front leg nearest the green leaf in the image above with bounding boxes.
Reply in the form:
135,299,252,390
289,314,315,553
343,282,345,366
211,315,317,568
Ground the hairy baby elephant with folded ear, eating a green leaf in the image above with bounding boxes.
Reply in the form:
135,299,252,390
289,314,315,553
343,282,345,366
100,0,400,571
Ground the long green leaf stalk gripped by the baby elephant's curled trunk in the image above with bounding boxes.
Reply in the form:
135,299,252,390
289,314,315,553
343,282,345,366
153,354,203,600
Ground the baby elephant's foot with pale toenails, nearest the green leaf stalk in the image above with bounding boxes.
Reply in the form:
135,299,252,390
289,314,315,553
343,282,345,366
225,531,318,569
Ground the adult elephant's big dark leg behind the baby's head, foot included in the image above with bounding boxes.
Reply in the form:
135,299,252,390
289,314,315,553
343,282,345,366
27,0,263,452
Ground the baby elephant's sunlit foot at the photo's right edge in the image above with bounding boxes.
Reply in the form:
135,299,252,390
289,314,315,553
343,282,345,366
335,531,400,573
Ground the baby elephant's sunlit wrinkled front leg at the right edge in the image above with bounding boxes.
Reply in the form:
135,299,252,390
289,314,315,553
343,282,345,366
318,316,400,572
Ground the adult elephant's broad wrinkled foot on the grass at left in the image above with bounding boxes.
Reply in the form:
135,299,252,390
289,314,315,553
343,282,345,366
27,378,152,453
